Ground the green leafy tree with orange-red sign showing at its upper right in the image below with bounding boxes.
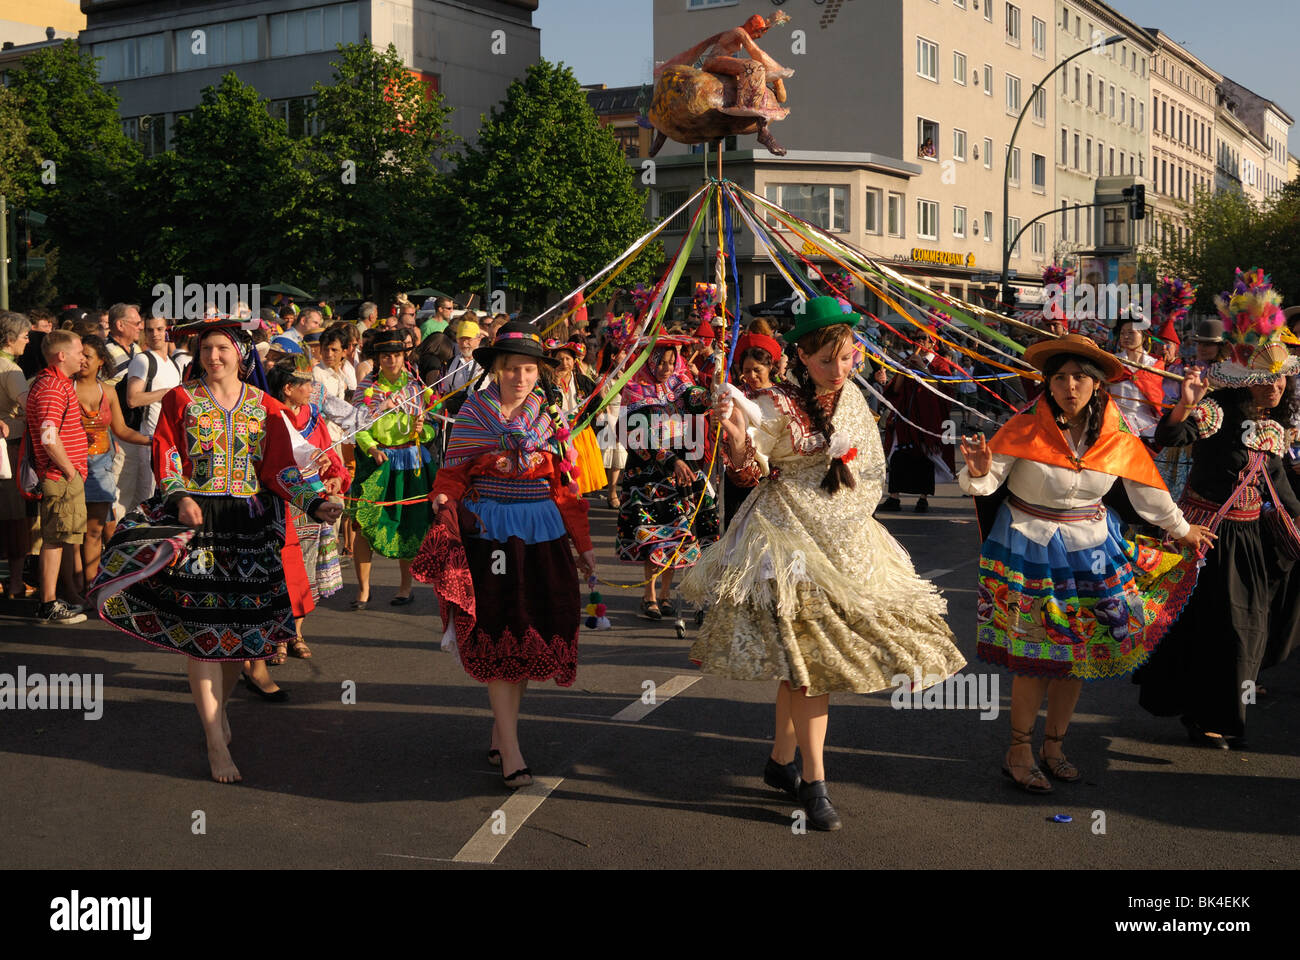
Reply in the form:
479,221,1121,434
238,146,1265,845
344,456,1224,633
311,39,458,297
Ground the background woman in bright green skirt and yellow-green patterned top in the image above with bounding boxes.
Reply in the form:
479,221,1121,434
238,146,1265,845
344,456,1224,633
350,330,434,600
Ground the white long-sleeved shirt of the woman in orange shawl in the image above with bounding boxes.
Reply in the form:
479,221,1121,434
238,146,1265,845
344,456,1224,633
957,433,1191,550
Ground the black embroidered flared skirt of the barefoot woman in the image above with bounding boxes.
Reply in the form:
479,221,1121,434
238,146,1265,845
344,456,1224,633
87,493,295,661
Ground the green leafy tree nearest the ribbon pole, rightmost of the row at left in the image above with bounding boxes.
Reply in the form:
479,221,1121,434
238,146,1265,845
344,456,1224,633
449,60,663,307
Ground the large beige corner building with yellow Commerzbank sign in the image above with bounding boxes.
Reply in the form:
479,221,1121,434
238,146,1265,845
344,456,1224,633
651,0,1066,308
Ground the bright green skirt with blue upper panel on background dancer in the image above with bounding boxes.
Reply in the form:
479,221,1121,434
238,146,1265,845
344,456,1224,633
348,444,434,559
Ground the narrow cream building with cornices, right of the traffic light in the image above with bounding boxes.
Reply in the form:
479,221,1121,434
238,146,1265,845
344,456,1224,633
1148,27,1223,257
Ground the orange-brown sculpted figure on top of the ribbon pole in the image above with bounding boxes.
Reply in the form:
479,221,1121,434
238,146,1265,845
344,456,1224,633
649,12,794,156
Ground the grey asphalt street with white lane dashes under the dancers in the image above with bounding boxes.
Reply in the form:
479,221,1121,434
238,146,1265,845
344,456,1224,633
0,485,1300,869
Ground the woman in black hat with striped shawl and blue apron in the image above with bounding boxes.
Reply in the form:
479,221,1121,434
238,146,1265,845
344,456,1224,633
412,321,595,788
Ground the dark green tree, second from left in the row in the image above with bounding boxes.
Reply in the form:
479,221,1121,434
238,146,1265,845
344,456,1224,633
145,73,315,286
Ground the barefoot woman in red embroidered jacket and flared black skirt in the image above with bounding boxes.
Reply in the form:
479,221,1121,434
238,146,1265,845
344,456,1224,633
90,320,342,783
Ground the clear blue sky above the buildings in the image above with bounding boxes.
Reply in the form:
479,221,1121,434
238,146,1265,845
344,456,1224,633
533,0,1300,156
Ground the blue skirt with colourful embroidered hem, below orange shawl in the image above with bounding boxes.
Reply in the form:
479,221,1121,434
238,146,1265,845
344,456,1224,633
975,503,1196,680
